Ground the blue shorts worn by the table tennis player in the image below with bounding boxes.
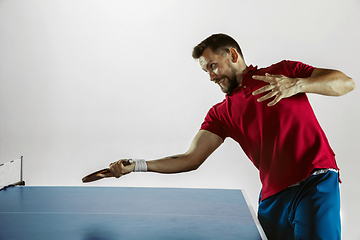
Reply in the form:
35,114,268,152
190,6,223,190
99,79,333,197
258,171,341,240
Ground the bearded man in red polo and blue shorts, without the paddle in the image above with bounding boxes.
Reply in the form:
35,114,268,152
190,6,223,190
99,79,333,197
104,34,355,240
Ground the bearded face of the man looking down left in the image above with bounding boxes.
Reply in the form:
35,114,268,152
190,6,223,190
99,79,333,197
199,48,239,94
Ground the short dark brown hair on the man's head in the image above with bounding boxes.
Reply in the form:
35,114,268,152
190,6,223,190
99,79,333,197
192,33,244,59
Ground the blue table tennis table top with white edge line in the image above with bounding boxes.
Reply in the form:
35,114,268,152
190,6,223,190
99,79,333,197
0,186,266,240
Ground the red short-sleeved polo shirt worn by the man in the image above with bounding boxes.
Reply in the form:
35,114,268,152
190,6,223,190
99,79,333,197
201,61,338,200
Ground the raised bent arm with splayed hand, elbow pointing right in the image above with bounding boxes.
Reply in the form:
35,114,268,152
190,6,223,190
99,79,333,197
253,68,355,106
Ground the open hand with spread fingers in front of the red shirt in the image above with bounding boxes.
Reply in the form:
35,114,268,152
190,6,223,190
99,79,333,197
252,73,298,107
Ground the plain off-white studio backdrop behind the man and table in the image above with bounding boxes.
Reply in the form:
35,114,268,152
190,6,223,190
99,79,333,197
0,0,360,239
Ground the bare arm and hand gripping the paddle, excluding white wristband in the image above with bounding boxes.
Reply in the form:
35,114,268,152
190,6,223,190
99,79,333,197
107,130,223,177
